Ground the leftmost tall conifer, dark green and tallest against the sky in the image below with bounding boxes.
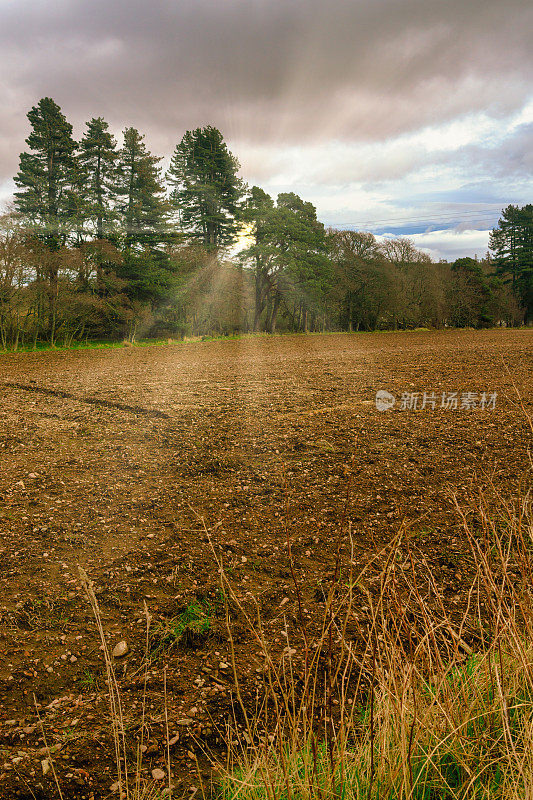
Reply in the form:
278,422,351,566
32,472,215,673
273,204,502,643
15,97,76,250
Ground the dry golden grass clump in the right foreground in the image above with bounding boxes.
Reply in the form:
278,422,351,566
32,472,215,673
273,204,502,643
214,468,533,800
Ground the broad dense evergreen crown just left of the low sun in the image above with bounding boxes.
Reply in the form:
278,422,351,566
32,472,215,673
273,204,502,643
167,125,243,249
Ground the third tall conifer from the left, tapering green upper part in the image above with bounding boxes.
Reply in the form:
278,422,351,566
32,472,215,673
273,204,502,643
114,128,169,250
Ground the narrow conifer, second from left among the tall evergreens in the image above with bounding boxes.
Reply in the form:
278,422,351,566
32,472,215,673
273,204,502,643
79,117,117,239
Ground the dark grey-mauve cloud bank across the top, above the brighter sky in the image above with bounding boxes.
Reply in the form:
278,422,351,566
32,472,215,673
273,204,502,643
0,0,532,179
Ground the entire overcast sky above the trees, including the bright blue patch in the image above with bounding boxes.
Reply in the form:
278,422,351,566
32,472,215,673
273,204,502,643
0,0,533,258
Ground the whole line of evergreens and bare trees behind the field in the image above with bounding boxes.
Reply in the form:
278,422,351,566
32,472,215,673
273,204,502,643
0,98,533,349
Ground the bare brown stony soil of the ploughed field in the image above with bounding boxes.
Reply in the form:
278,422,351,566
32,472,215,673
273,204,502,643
0,330,533,798
